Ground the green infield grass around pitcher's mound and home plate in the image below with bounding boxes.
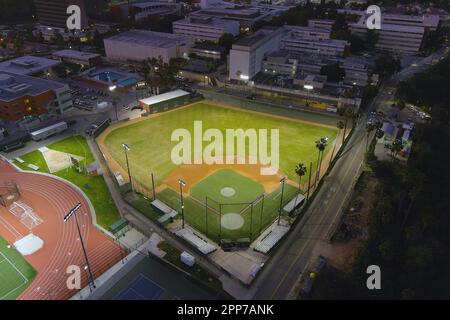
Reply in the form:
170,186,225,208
157,169,298,242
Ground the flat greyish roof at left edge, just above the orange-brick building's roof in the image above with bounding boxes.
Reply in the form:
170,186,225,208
0,56,60,75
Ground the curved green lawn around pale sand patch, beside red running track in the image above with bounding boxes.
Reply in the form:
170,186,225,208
15,136,120,229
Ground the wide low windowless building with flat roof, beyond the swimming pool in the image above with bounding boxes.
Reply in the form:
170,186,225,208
104,30,194,63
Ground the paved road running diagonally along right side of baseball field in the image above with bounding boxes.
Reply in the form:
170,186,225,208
253,49,446,299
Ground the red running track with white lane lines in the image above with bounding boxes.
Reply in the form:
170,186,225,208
0,159,125,300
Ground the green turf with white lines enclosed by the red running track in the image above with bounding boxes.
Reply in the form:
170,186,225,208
0,237,37,300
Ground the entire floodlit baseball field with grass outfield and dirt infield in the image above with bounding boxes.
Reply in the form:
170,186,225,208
97,102,338,240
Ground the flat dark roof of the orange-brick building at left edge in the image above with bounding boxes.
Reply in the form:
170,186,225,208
0,72,64,101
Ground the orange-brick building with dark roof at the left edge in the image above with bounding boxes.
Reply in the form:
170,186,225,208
0,72,72,121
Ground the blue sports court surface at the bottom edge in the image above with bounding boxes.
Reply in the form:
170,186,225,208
115,273,165,300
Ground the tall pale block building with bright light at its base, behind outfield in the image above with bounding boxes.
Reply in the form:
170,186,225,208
229,27,282,81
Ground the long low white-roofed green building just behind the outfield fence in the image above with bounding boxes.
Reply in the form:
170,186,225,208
139,89,191,113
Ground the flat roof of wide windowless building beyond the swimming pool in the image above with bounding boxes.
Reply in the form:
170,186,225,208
105,30,191,48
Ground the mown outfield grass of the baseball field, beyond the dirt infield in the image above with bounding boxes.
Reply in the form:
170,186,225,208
104,103,337,189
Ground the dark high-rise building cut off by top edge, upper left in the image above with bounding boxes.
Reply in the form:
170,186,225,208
34,0,88,29
